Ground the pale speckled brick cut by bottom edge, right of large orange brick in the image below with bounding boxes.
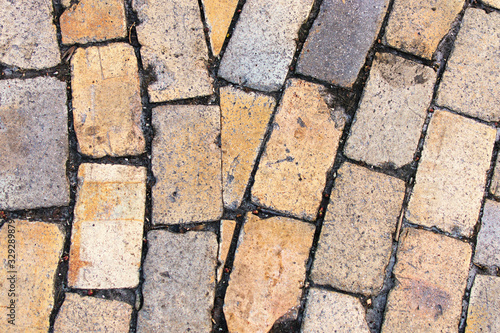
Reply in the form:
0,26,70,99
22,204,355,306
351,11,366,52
301,288,370,333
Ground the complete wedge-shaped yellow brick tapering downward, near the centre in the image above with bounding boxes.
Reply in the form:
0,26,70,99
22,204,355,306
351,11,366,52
220,86,276,209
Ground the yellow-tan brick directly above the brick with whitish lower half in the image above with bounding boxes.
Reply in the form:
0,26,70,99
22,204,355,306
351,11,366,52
71,43,145,157
